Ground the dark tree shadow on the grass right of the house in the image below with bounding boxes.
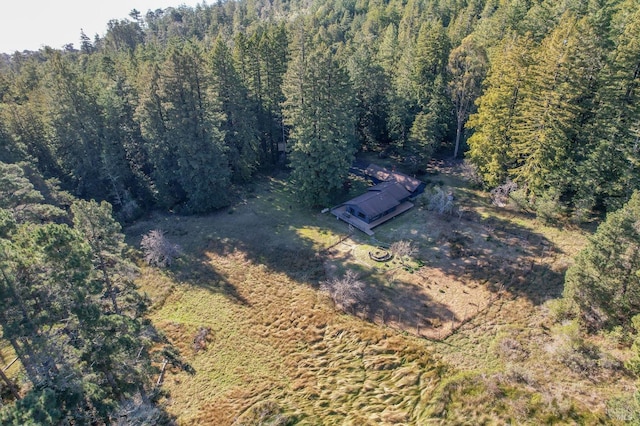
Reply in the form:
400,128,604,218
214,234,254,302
378,206,566,305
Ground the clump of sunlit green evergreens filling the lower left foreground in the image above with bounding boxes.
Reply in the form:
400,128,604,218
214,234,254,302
0,193,167,424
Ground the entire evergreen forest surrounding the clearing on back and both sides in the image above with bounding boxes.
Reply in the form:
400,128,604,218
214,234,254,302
0,0,640,424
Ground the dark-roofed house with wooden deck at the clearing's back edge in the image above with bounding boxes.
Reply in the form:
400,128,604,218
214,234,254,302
331,181,413,235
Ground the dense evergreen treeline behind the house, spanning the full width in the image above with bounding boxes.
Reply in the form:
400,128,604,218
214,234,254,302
0,0,640,219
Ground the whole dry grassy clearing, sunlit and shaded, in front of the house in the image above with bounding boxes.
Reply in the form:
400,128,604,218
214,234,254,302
122,164,633,425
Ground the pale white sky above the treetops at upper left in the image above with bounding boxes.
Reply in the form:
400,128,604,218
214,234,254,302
0,0,204,53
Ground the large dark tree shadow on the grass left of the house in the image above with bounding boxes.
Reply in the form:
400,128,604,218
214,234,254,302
127,176,325,304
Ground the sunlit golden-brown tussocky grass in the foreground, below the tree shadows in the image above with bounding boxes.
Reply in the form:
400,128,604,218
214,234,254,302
144,245,444,424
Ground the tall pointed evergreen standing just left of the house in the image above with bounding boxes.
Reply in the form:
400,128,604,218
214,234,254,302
284,26,356,205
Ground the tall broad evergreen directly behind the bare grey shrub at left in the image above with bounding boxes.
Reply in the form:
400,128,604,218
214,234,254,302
138,40,230,212
